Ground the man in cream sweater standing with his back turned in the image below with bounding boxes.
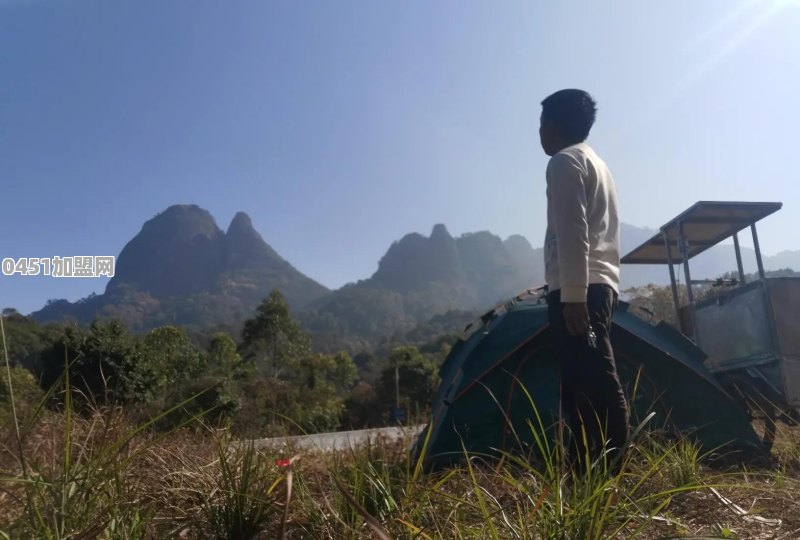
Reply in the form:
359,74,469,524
539,90,628,471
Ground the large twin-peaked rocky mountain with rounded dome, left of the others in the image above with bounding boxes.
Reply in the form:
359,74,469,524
32,204,329,330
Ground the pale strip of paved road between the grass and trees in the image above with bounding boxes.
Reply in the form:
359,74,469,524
254,425,425,452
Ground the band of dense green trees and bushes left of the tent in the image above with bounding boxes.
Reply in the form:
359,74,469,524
0,290,450,436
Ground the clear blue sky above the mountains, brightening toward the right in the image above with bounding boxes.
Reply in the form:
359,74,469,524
0,0,800,312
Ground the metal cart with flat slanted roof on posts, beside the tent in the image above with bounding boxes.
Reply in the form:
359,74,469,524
622,201,800,445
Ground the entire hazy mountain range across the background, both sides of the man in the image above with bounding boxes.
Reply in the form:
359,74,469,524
32,205,800,347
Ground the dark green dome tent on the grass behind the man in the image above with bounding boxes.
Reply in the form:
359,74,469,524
418,296,762,465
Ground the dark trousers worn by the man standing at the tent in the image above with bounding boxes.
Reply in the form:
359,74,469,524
547,284,628,471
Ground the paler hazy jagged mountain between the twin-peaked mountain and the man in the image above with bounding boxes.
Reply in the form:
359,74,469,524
300,224,543,343
